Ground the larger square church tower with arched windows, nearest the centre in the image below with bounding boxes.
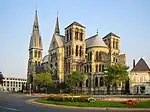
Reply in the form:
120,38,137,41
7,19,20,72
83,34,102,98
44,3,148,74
64,22,86,74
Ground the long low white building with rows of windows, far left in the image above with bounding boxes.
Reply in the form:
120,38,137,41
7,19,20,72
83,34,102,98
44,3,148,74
2,77,27,92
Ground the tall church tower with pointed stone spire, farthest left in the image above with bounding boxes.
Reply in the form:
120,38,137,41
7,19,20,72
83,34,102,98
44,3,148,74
27,10,43,88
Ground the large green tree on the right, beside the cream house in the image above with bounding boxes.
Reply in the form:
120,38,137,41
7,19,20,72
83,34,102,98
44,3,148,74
104,64,129,94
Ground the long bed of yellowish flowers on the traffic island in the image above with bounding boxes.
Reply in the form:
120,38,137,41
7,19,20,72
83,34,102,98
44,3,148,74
44,94,95,102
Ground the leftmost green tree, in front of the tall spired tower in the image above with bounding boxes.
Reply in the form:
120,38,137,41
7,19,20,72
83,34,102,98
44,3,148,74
34,71,52,93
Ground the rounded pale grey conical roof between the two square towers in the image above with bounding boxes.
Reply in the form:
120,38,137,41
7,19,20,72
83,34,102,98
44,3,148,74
86,34,107,48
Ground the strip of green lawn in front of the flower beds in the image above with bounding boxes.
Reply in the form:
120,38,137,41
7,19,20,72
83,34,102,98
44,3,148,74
36,98,150,108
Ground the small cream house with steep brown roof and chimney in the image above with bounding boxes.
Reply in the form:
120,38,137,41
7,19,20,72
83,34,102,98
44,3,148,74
130,58,150,94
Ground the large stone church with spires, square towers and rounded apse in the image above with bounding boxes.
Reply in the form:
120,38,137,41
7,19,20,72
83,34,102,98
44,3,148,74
27,11,126,92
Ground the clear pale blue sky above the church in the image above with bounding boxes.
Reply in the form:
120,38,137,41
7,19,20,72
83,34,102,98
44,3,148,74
0,0,150,78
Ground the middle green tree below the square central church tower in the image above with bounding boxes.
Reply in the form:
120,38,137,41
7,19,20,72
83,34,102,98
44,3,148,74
66,71,85,89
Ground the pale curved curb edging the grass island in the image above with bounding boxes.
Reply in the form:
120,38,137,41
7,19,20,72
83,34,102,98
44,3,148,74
27,99,150,111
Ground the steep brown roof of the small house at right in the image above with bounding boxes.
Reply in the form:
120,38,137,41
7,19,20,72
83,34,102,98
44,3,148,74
131,58,150,72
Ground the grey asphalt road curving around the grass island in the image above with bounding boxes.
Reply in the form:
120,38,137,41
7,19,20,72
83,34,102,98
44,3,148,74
0,92,150,112
